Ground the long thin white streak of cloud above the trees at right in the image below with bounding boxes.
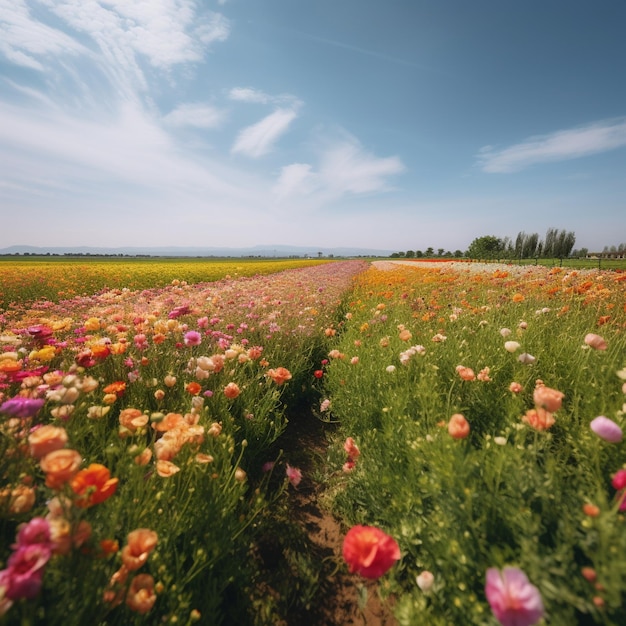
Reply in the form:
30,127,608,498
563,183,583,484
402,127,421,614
477,120,626,173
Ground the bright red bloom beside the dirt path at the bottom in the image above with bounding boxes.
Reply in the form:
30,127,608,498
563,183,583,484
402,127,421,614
343,526,402,578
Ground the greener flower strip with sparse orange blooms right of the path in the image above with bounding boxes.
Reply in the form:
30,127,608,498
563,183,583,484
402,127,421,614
320,263,626,626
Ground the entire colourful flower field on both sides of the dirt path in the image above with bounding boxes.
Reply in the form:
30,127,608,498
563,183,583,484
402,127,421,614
0,261,626,626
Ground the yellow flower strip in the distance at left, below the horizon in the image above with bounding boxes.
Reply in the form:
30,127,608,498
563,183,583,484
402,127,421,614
0,256,329,311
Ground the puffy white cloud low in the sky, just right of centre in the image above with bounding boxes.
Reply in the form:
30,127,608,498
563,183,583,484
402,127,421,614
274,138,405,200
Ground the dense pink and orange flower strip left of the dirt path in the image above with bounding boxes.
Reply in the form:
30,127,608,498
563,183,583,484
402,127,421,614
0,262,364,624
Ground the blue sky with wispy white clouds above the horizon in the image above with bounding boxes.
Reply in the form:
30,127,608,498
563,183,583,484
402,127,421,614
0,0,626,251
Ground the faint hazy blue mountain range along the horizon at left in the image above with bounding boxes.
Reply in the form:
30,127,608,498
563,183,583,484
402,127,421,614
0,245,393,258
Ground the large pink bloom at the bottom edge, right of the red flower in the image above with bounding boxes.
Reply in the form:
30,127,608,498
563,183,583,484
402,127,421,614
485,567,544,626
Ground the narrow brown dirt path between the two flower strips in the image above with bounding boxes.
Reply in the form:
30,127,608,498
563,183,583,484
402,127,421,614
282,414,397,626
